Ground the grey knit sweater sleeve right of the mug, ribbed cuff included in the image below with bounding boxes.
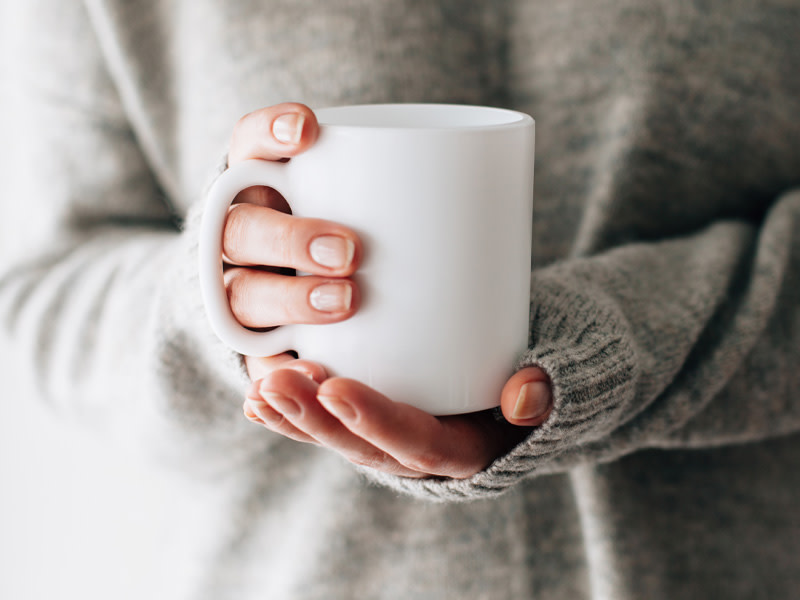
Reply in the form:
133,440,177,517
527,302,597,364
368,190,800,501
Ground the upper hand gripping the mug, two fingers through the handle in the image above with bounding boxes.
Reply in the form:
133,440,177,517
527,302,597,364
222,103,361,344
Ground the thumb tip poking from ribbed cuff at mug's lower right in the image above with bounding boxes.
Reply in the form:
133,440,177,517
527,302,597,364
500,367,553,427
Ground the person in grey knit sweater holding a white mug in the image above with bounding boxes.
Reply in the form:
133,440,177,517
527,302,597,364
0,0,800,600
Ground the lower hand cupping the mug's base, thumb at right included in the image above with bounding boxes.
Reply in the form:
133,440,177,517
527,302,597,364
244,358,552,479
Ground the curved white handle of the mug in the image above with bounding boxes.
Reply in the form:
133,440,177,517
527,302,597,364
198,159,296,356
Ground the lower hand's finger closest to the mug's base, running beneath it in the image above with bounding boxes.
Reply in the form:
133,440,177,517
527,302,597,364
318,378,497,479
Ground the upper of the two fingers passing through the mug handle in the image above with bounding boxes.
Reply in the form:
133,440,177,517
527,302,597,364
222,204,361,277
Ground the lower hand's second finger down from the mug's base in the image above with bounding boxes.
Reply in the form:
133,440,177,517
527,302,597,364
259,369,426,478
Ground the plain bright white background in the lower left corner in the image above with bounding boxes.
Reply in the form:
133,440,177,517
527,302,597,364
0,350,213,600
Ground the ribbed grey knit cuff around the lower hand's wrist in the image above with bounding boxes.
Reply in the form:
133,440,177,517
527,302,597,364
362,270,638,502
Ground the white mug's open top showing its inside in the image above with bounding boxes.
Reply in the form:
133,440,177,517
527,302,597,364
315,104,530,129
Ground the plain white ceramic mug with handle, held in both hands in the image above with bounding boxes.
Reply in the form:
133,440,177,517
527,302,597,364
200,104,534,415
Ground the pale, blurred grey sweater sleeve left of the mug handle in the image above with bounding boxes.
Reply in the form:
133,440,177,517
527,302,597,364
0,1,266,472
